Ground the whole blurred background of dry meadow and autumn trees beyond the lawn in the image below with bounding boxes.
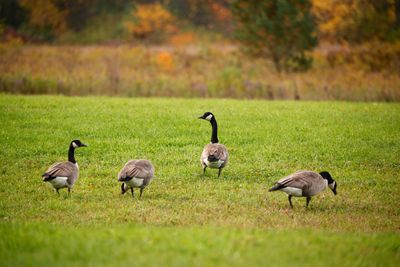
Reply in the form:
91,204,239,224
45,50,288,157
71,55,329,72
0,0,400,101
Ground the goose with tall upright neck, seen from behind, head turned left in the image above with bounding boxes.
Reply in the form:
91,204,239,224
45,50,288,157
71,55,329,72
199,112,228,177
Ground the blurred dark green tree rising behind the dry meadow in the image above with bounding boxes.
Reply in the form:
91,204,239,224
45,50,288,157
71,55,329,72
232,0,317,72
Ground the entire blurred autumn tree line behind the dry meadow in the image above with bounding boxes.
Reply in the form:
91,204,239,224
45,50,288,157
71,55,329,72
0,0,400,71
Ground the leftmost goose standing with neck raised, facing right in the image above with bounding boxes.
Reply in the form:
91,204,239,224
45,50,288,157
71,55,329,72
42,140,86,195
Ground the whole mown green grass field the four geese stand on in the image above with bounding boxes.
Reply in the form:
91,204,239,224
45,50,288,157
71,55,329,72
0,95,400,266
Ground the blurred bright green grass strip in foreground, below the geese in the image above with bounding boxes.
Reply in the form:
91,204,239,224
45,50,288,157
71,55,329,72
0,224,400,266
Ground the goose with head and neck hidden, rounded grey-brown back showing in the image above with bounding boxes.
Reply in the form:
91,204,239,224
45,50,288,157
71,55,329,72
118,159,154,198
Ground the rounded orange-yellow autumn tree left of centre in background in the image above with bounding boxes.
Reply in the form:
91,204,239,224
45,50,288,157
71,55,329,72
124,3,177,38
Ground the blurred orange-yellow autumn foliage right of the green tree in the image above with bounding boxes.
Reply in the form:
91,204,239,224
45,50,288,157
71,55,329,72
312,0,400,43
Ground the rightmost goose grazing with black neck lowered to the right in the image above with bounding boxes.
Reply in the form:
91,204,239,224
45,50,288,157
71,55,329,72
269,171,337,208
